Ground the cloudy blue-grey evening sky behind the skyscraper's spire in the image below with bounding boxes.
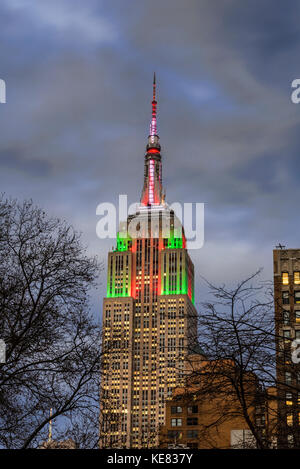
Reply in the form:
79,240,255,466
0,0,300,314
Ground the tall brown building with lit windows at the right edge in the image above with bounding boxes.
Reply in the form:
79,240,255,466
273,247,300,448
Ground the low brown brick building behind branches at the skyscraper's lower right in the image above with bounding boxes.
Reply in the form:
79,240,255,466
160,357,265,449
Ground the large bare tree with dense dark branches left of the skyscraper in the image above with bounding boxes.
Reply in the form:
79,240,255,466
0,197,101,448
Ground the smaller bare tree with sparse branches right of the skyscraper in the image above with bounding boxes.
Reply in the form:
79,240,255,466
192,271,286,448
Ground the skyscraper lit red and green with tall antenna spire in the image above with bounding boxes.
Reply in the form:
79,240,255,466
100,75,197,448
